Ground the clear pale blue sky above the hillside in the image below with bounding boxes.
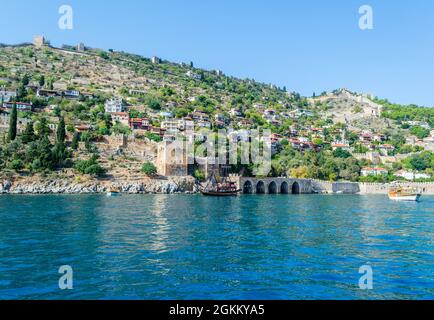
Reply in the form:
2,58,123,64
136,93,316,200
0,0,434,106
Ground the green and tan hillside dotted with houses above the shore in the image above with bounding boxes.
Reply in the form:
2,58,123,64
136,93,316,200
0,40,434,185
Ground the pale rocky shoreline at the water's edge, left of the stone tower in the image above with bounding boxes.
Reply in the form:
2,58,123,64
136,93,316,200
0,177,197,194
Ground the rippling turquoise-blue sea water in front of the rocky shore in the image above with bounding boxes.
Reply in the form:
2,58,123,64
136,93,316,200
0,195,434,299
